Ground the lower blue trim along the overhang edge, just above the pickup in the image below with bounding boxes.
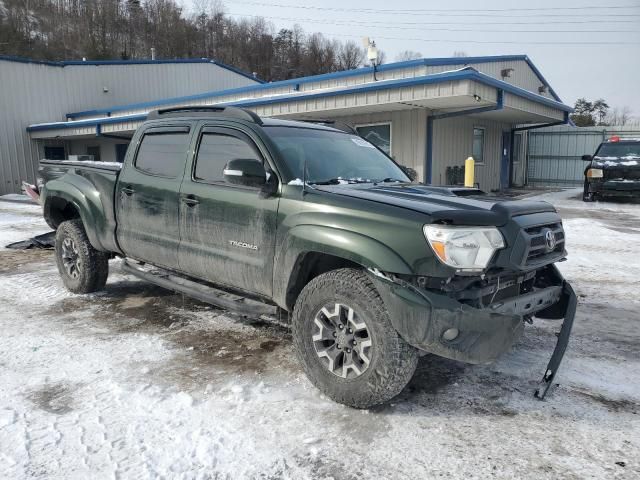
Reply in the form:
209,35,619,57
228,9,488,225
27,68,573,131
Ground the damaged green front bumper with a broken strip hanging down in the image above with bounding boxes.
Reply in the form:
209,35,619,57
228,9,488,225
372,266,577,399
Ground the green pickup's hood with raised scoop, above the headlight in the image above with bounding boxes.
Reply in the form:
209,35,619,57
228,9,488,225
315,184,556,226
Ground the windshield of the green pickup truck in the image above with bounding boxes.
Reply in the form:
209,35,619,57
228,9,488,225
265,126,411,184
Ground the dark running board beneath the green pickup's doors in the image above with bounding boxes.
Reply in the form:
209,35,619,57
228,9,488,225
122,260,279,318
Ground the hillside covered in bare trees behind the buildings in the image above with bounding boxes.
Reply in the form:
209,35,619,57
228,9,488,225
0,0,365,80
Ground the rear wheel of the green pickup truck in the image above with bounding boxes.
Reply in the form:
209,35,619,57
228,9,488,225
55,219,109,293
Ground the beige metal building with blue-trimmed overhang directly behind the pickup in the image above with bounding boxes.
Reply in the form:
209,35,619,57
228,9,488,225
5,55,571,190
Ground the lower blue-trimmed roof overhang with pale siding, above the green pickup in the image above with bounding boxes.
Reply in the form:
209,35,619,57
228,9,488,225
28,67,572,138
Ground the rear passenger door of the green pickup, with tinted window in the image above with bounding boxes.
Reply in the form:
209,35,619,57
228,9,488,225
116,123,191,269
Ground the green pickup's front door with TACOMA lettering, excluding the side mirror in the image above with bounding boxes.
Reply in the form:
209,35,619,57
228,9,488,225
180,125,278,296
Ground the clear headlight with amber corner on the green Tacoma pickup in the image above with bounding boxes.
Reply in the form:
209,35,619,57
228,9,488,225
424,225,505,272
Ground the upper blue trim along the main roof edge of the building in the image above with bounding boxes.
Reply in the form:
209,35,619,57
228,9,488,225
67,55,562,118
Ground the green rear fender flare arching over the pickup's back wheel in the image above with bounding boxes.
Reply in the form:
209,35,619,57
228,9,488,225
43,176,109,251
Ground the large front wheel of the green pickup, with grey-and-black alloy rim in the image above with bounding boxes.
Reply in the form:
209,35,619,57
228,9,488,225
292,269,418,408
